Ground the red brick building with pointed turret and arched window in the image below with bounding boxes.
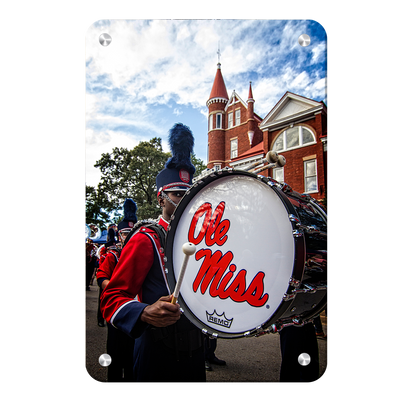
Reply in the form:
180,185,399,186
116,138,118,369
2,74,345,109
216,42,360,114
207,63,330,200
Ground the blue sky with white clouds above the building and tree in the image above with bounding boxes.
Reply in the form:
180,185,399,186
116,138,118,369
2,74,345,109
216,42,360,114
82,17,330,186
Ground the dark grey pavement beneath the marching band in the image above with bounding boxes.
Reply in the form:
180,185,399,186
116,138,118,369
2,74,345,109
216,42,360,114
82,280,330,385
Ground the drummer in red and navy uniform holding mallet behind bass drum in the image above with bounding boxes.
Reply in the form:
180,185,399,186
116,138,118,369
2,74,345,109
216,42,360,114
101,123,206,385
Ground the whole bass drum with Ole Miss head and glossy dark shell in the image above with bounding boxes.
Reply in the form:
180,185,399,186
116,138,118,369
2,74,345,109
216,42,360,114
165,170,329,339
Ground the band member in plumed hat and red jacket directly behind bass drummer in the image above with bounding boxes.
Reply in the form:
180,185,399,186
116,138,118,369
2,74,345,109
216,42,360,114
97,199,137,386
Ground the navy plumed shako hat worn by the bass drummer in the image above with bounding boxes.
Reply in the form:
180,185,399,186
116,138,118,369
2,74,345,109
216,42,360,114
156,123,196,196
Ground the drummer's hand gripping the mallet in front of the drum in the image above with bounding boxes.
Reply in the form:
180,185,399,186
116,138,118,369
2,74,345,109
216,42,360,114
140,294,181,327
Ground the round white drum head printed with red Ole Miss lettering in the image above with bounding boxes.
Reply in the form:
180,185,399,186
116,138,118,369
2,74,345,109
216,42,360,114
167,175,295,337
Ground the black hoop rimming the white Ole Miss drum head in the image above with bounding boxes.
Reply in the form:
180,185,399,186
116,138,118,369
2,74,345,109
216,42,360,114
165,170,305,339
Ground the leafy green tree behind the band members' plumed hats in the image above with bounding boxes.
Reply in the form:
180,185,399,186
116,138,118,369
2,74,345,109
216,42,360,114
94,138,205,220
